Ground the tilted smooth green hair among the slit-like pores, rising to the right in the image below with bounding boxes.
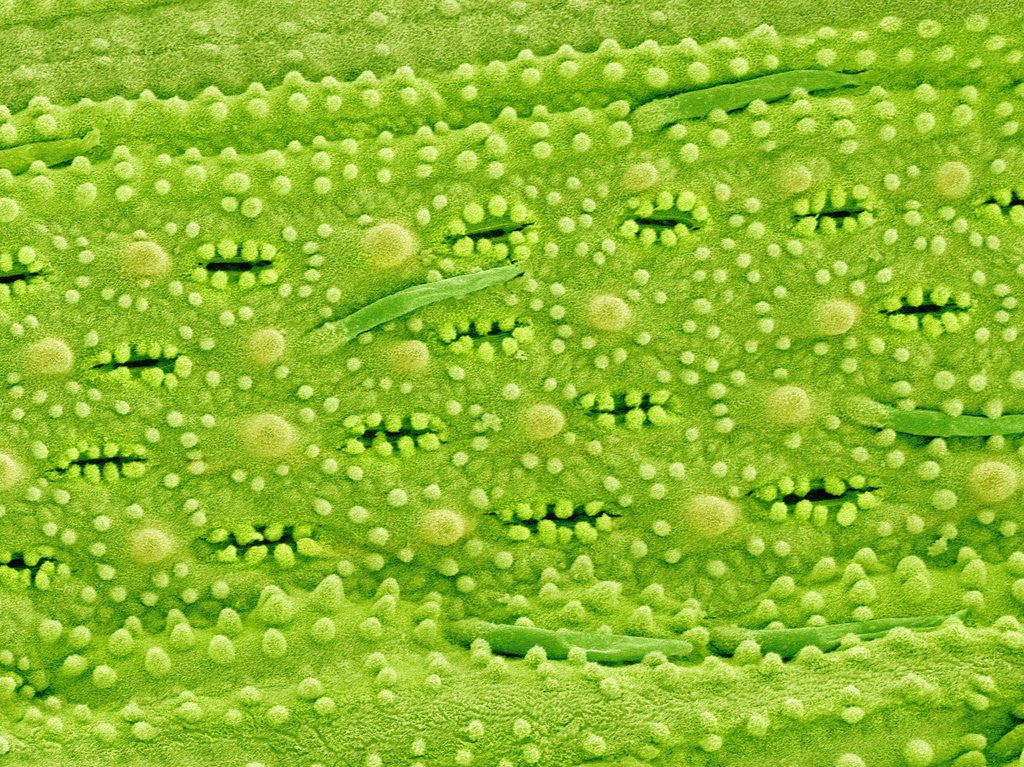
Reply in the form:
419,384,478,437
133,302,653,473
315,265,522,354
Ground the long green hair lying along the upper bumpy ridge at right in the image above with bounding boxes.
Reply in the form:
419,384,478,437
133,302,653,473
633,70,860,133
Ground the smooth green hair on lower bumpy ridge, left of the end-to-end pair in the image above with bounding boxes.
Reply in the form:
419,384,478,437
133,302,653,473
453,620,693,663
